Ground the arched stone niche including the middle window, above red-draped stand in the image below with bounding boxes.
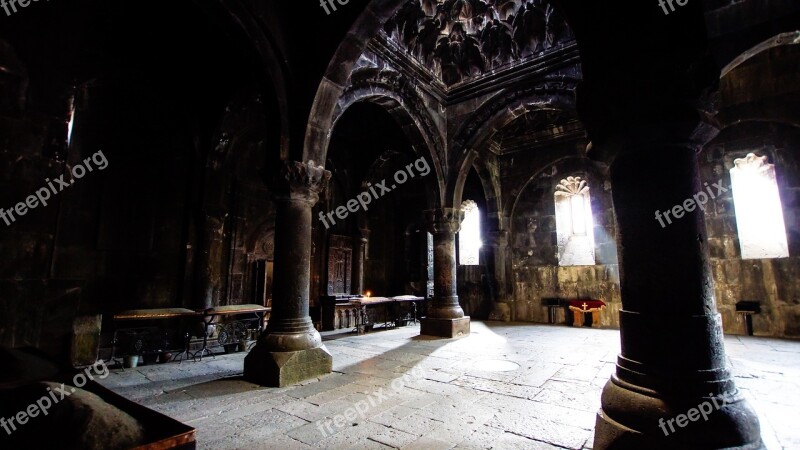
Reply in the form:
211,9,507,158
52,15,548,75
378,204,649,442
510,159,621,327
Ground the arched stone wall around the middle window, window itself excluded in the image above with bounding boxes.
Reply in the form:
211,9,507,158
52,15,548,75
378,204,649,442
510,158,621,327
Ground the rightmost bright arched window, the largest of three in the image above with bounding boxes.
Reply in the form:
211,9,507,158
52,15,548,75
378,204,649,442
731,153,789,259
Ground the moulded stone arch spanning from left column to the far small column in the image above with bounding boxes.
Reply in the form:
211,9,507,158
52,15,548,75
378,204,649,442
325,69,446,208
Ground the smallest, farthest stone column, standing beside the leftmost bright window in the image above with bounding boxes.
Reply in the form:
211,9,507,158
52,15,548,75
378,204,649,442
421,208,469,338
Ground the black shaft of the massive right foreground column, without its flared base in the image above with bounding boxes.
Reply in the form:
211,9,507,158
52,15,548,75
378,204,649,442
611,144,730,388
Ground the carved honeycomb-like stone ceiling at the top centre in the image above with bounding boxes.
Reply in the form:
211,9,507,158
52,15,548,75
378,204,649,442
384,0,573,86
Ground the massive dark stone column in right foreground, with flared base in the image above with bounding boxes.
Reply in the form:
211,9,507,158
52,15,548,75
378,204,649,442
594,137,762,449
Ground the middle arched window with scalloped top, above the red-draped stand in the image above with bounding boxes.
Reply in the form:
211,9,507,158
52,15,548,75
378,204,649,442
555,177,595,266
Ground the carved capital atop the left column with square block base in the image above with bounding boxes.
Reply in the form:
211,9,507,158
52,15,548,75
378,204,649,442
272,161,331,206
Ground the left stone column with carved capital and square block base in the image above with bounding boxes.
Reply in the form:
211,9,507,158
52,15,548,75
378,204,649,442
244,161,333,387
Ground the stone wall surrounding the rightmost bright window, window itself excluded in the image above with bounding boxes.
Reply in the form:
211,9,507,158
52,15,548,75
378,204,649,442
700,123,800,337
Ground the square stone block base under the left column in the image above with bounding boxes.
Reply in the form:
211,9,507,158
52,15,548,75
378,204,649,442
244,345,333,387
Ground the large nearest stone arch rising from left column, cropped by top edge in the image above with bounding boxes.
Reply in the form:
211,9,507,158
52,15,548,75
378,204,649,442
303,0,591,174
